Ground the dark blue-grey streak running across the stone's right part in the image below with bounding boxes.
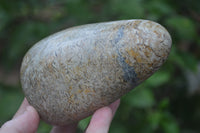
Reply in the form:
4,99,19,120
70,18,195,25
112,26,138,85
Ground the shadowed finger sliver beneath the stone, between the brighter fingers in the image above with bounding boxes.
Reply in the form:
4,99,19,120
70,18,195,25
51,123,77,133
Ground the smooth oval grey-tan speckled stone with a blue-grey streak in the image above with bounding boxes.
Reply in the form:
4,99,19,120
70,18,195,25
21,20,171,125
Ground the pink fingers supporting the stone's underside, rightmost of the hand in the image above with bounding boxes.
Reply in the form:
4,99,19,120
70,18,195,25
86,100,120,133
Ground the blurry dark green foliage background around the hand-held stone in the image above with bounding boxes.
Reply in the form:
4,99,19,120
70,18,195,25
0,0,200,133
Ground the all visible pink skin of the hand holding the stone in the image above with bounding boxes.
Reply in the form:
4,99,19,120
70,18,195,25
0,98,120,133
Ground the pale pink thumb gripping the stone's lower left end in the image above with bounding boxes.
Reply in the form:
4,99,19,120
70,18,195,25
0,106,39,133
